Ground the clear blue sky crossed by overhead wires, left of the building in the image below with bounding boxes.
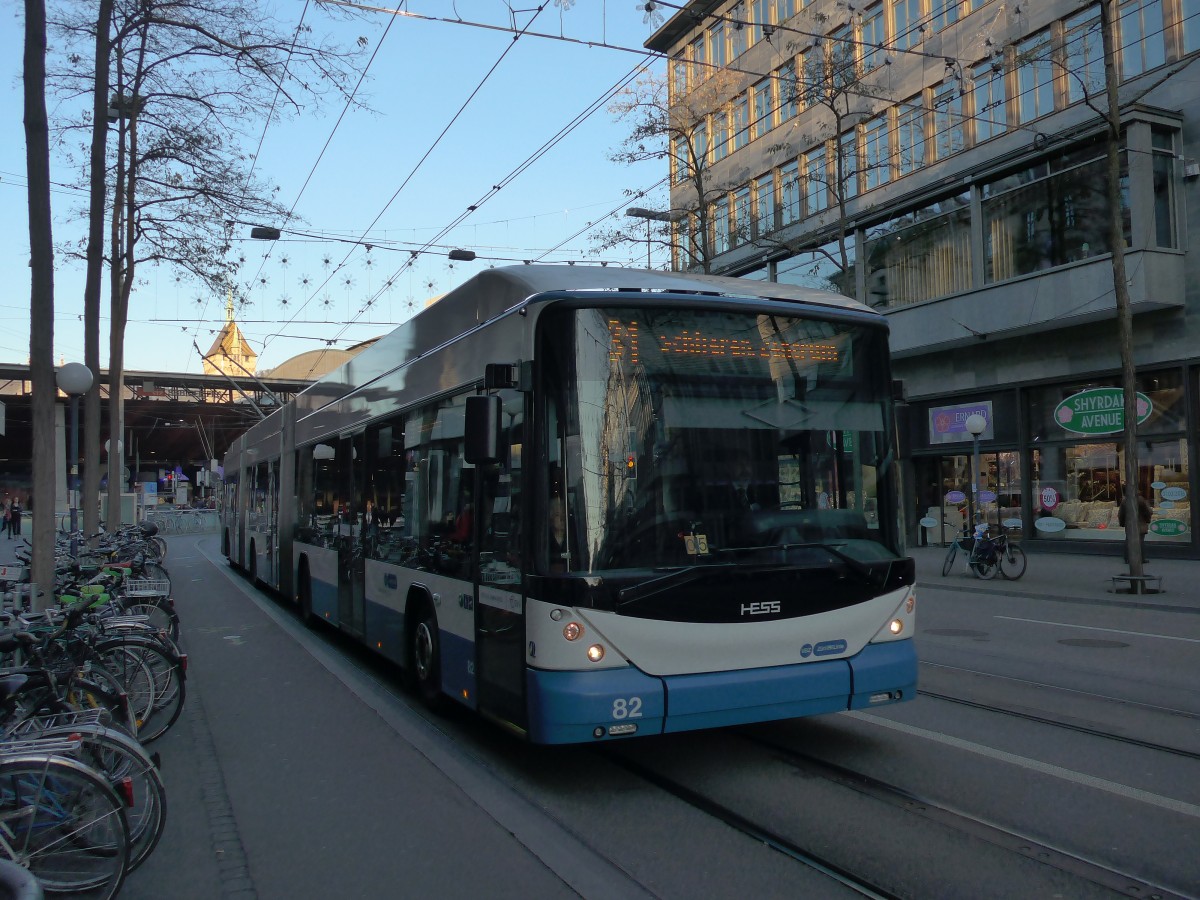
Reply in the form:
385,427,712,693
0,0,670,372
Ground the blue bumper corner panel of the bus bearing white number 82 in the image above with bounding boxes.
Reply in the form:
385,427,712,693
526,666,664,744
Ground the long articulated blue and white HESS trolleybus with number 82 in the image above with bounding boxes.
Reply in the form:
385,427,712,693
223,266,917,744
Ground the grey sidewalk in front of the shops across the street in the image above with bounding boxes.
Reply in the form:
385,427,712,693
907,545,1200,612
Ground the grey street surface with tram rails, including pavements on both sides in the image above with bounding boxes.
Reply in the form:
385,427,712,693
112,536,1200,900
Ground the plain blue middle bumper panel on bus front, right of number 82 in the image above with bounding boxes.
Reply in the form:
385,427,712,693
664,660,851,732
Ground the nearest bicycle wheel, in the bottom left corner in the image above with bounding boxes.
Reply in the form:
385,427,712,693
0,755,130,900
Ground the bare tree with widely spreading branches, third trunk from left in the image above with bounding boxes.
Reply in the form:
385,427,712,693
54,0,366,528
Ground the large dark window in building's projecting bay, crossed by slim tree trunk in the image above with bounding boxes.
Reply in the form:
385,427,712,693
983,138,1130,282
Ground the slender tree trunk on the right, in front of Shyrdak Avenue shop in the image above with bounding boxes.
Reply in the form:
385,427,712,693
1100,0,1145,575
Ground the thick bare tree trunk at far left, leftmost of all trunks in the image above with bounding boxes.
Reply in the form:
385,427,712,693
24,0,60,611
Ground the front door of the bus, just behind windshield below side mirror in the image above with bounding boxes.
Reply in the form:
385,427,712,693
475,390,527,730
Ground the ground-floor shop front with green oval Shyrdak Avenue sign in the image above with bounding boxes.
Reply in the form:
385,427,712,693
910,368,1200,558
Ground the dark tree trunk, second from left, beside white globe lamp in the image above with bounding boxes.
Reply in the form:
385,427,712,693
80,0,113,535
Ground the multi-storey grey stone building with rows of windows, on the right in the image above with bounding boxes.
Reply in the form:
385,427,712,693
647,0,1200,559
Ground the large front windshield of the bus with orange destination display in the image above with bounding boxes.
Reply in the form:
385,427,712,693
541,306,898,572
